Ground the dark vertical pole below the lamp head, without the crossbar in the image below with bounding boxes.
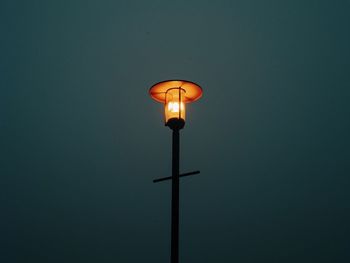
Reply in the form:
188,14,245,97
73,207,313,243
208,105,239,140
171,129,180,263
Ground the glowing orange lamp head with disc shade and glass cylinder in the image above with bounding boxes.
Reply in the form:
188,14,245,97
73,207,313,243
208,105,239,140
149,80,202,127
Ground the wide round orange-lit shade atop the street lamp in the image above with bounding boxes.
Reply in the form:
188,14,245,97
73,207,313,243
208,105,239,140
149,80,203,103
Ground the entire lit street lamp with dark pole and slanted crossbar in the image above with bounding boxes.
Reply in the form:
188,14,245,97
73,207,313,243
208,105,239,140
149,80,202,263
